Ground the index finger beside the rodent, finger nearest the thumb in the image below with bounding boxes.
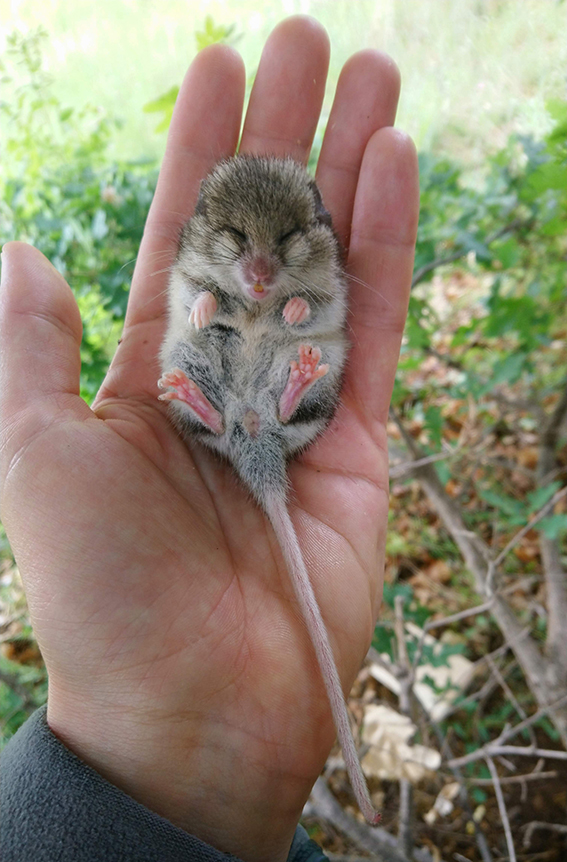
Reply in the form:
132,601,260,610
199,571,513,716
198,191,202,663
95,44,245,404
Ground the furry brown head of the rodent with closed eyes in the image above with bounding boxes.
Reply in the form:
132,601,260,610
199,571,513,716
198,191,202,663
179,156,339,302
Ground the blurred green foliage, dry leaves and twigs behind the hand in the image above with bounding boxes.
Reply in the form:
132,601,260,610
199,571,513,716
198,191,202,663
0,0,567,860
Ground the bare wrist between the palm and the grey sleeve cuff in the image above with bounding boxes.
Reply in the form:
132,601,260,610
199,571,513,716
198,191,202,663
47,686,312,862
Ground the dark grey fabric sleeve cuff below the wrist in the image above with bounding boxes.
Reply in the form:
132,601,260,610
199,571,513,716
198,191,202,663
0,707,326,862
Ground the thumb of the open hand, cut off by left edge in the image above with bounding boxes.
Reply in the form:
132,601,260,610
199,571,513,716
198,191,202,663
0,242,90,480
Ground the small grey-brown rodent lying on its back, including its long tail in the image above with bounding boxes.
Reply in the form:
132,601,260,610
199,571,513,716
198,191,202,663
158,155,380,823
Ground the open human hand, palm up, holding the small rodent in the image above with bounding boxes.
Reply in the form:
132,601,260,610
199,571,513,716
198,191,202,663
0,17,418,862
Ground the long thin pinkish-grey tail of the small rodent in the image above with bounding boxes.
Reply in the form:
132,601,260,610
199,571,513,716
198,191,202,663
264,494,381,825
